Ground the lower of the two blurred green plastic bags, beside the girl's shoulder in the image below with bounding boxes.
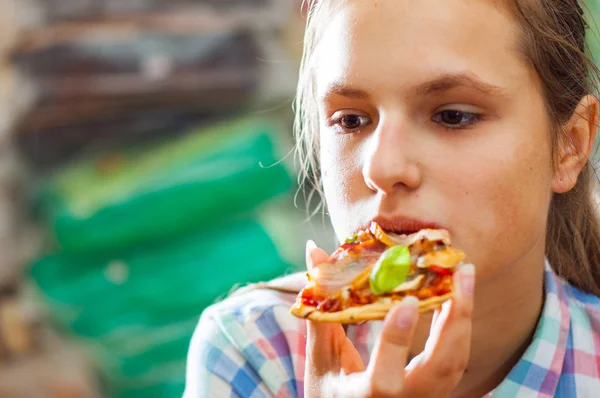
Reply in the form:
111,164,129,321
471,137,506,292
30,217,294,398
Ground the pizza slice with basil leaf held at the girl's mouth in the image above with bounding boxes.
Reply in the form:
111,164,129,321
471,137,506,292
290,222,465,323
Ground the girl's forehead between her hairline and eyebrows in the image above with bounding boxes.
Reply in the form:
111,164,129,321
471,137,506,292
314,0,531,97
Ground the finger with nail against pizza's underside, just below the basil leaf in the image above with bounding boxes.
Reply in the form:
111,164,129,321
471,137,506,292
367,296,419,397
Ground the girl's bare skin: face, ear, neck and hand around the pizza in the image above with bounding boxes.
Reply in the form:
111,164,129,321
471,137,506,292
305,0,598,397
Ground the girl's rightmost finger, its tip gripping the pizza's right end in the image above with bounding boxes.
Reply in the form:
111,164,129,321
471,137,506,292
406,264,475,396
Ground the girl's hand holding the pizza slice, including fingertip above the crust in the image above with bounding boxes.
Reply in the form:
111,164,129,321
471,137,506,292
304,242,475,398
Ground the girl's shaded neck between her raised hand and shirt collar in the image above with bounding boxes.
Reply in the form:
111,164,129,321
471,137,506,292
413,250,544,398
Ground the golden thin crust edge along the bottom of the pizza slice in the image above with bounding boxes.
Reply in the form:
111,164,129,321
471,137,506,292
290,293,454,323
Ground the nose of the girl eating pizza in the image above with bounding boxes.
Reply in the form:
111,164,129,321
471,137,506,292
362,120,421,196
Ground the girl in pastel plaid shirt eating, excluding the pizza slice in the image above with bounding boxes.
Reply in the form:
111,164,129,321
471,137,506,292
186,0,600,398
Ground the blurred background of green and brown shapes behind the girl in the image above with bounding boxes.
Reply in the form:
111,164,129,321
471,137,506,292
0,0,600,398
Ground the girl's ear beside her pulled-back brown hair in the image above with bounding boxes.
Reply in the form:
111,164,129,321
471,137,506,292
552,95,598,193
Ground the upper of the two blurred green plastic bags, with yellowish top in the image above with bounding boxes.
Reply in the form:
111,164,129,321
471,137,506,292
38,119,291,252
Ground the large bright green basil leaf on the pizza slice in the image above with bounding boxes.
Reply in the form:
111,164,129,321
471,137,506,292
369,246,410,295
